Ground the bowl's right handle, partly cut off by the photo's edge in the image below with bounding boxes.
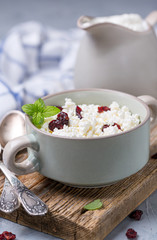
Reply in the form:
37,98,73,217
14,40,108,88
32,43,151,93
138,95,157,129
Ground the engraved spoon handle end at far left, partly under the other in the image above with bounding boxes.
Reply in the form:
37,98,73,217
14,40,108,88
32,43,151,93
0,178,20,213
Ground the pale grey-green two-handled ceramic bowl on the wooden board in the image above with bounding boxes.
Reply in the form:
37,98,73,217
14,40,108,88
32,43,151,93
4,89,157,187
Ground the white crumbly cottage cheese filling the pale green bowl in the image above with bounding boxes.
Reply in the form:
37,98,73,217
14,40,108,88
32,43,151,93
41,98,140,138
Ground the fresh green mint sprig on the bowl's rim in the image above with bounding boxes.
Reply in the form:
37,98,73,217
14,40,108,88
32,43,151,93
22,98,60,128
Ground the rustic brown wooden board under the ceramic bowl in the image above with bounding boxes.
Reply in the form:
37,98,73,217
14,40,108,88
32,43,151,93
0,127,157,240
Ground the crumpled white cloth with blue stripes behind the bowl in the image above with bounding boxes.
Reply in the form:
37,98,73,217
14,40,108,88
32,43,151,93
0,22,83,119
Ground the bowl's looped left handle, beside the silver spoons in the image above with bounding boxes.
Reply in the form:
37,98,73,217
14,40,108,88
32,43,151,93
3,134,39,175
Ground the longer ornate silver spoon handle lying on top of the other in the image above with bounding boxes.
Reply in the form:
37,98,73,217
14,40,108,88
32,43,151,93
0,161,47,215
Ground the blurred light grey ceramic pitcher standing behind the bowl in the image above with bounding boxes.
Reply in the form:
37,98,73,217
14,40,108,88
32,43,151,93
74,11,157,97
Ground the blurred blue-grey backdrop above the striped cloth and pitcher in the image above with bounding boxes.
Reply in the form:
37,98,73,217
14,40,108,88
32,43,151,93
0,0,157,37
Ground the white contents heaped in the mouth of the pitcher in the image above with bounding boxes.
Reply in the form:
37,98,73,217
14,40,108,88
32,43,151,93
91,13,148,31
